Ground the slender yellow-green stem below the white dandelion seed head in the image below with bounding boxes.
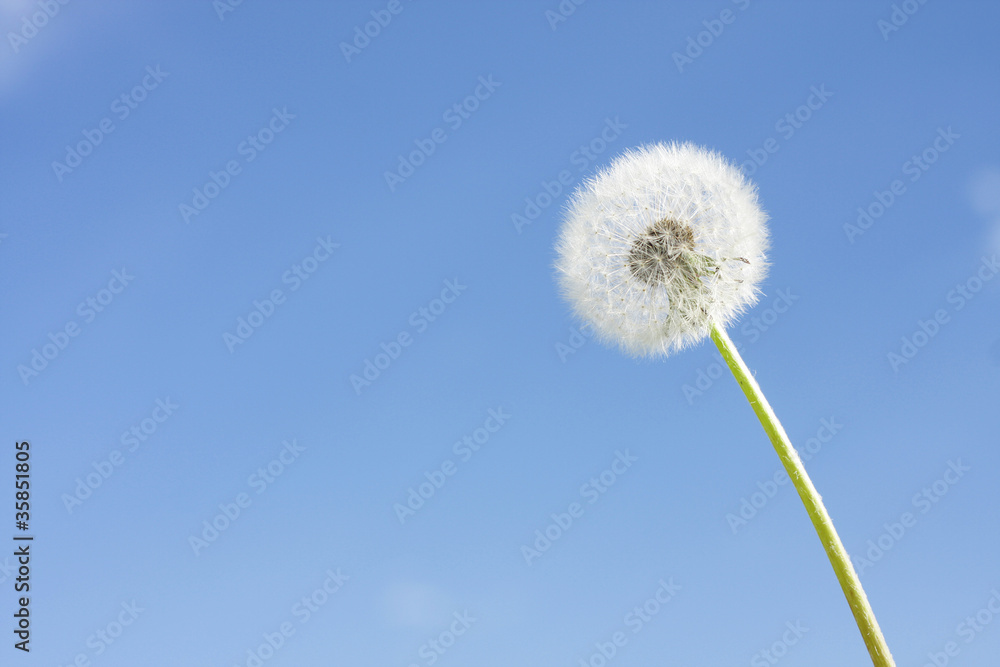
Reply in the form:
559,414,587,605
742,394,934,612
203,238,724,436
712,324,896,667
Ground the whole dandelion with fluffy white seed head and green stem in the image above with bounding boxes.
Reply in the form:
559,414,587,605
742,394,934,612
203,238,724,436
556,144,895,667
